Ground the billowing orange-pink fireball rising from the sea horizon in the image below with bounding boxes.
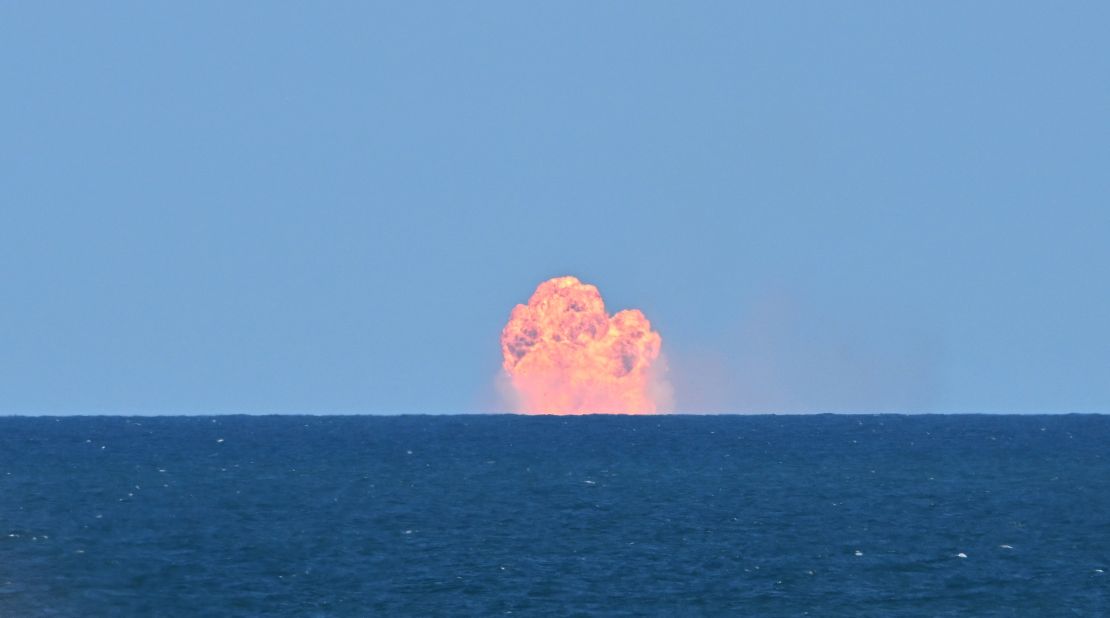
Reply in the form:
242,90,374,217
501,276,670,414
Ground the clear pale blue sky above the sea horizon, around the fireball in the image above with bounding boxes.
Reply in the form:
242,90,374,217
0,1,1110,415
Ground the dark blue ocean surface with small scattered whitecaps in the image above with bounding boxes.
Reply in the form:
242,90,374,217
0,415,1110,618
